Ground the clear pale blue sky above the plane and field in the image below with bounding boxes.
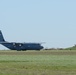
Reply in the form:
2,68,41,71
0,0,76,49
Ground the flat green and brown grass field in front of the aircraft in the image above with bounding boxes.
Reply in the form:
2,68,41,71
0,50,76,75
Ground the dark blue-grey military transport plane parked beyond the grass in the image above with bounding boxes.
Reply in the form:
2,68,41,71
0,30,44,51
